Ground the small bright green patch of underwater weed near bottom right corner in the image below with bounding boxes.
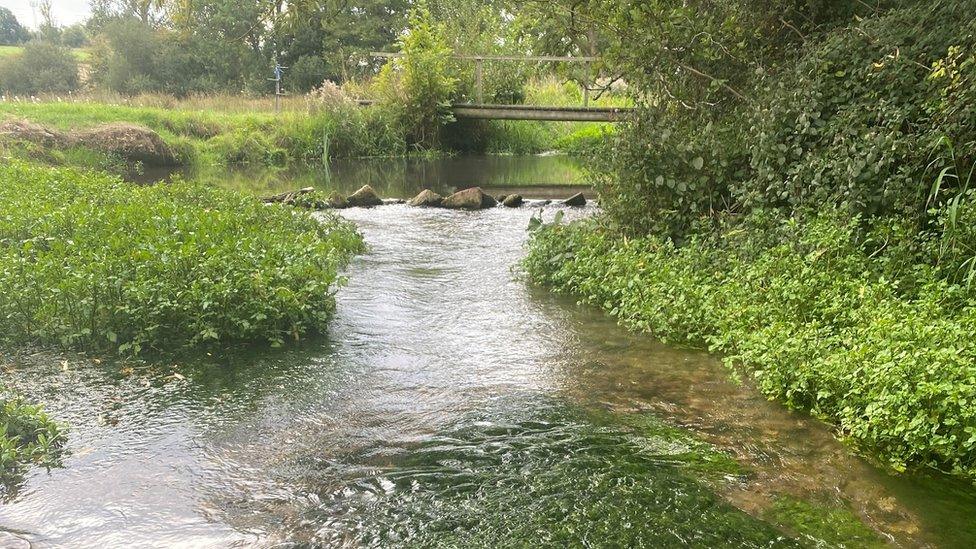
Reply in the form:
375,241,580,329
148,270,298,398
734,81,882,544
766,496,887,548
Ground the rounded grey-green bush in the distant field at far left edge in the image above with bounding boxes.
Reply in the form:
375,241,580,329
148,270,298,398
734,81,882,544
0,42,79,95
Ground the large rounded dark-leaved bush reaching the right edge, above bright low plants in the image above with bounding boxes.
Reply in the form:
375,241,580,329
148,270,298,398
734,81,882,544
735,0,976,222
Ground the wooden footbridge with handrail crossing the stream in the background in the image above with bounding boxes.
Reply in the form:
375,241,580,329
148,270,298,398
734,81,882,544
359,52,633,122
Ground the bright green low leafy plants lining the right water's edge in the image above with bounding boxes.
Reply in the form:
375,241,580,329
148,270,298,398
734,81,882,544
525,215,976,478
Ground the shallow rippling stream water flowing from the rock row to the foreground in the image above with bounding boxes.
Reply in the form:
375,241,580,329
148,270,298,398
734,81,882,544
0,156,976,547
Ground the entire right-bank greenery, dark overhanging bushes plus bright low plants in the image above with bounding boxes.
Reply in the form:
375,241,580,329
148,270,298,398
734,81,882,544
526,0,976,478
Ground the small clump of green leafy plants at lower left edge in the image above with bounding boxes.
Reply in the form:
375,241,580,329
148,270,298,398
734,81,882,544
0,387,65,493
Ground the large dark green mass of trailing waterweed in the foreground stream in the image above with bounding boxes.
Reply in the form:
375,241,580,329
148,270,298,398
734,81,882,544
305,405,803,547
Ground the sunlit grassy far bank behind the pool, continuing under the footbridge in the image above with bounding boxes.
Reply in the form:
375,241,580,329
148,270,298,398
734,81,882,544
0,90,613,173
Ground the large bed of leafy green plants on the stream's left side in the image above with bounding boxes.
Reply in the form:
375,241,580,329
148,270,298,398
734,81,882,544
0,162,362,355
